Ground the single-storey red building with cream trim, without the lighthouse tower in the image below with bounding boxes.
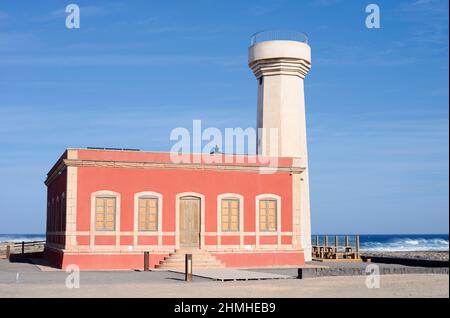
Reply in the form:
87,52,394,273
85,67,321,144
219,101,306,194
45,149,304,269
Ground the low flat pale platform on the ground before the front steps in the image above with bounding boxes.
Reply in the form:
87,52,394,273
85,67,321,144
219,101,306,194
171,268,297,282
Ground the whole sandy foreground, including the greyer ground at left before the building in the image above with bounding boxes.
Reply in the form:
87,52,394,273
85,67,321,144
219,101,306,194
0,261,449,298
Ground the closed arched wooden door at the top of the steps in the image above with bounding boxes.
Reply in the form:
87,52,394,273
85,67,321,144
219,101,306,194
179,197,200,247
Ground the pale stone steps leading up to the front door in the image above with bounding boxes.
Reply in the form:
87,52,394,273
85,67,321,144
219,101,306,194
156,248,225,270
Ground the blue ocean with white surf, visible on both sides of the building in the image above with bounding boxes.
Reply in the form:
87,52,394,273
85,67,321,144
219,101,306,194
0,234,449,252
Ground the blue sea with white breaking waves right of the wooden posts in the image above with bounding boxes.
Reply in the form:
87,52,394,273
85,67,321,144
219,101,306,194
361,238,449,252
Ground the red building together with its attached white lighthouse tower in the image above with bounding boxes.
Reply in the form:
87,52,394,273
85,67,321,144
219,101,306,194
45,33,311,269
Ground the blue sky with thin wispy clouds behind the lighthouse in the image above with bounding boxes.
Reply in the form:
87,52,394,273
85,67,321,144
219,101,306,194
0,0,449,233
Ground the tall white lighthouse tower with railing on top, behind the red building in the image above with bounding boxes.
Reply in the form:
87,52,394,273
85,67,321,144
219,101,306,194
248,31,311,261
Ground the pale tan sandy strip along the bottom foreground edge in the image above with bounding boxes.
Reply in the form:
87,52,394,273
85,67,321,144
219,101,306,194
0,275,449,298
